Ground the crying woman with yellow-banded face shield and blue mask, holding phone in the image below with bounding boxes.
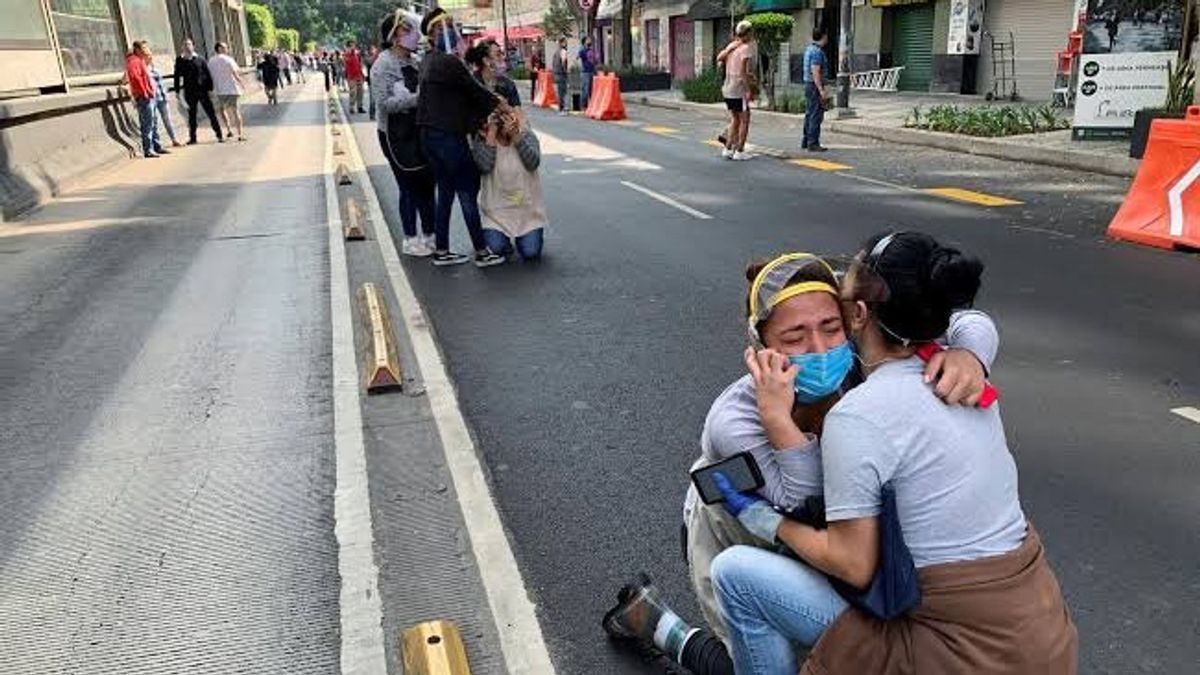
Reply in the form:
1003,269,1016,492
604,252,998,675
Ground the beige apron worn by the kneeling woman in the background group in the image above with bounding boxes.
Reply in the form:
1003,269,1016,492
479,140,548,238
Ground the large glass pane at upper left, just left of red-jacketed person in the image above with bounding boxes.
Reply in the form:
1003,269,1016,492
50,0,125,77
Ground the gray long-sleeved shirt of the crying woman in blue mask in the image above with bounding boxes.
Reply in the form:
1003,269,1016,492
684,310,1000,519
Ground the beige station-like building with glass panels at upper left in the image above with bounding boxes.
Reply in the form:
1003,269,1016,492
0,0,250,97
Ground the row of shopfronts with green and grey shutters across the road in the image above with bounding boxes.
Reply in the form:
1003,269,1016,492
599,0,1087,101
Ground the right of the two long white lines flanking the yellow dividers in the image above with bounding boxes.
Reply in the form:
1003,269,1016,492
338,97,554,675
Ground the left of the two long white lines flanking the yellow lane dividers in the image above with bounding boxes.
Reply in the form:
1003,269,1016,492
324,88,388,675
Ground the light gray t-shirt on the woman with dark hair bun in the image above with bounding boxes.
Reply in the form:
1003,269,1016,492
821,357,1025,568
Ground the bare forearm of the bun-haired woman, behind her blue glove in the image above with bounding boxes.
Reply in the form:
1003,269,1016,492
776,518,880,589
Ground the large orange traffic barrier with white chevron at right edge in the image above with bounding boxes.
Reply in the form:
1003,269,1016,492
1109,106,1200,249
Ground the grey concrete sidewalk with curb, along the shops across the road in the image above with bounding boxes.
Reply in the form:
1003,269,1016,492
625,90,1140,177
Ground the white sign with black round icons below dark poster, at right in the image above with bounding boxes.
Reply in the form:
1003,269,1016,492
1074,52,1177,139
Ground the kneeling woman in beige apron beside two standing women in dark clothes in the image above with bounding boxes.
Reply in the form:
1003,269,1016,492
470,108,548,261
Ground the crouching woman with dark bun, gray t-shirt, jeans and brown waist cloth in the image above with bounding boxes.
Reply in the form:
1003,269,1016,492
712,228,1078,675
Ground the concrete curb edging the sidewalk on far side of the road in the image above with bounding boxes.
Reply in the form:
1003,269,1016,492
632,96,1141,178
